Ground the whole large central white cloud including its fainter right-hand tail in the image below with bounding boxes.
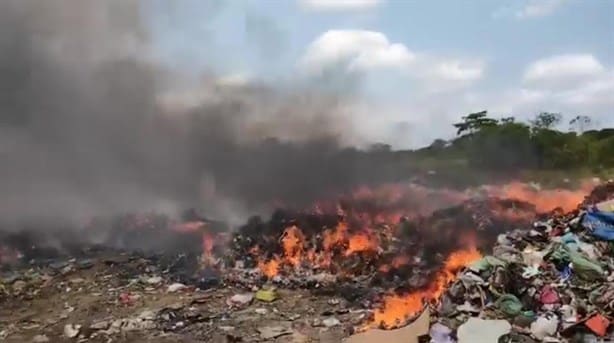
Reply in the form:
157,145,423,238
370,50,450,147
300,30,484,92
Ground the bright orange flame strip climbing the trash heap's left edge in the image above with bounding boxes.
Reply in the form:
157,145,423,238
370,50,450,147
373,247,482,328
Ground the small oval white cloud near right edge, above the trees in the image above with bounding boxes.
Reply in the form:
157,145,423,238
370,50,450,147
523,54,605,87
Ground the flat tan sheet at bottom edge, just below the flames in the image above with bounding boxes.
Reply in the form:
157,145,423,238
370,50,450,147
344,309,430,343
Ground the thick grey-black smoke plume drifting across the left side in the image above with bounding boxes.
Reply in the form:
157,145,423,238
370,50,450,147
0,0,384,226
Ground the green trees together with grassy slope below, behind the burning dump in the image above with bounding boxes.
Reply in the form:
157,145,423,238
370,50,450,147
371,111,614,186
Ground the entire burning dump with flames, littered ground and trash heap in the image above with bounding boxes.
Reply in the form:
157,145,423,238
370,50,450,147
0,184,614,343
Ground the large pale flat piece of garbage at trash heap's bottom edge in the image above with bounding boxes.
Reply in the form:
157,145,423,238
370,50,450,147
457,318,512,343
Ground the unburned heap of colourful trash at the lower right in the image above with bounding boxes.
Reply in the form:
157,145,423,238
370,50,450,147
429,185,614,343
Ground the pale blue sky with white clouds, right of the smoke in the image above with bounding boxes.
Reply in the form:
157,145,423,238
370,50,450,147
147,0,614,148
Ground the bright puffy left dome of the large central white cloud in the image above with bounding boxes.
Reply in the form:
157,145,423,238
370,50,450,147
301,30,415,71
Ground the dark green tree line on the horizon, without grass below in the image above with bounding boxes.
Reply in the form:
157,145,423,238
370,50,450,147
424,111,614,171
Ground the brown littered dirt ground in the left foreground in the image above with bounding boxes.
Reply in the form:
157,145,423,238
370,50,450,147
0,262,366,343
